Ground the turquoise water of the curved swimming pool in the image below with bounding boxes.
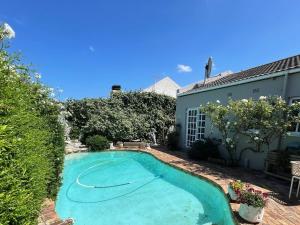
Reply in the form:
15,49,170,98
56,151,235,225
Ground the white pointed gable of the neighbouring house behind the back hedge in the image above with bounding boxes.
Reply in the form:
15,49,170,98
143,77,180,98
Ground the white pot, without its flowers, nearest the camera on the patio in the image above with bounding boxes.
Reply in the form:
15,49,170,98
239,203,265,223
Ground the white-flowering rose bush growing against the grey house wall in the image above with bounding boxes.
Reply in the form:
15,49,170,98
201,96,300,164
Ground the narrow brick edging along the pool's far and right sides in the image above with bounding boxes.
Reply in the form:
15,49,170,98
88,148,240,225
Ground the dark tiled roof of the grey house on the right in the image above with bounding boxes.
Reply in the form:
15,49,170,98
183,55,300,94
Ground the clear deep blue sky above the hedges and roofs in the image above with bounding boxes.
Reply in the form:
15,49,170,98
0,0,300,99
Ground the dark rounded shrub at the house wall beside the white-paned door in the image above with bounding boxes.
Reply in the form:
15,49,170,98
188,139,219,160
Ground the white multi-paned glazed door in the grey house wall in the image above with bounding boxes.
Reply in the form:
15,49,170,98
185,108,206,148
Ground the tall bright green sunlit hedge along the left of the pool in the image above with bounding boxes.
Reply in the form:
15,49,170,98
0,46,64,222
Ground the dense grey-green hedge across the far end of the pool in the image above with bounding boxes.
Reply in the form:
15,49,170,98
66,92,176,142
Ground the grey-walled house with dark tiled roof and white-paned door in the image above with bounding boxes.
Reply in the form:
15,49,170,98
176,55,300,169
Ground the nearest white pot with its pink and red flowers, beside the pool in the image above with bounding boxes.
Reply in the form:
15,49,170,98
239,188,268,223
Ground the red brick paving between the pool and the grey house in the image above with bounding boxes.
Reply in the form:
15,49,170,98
142,149,300,225
